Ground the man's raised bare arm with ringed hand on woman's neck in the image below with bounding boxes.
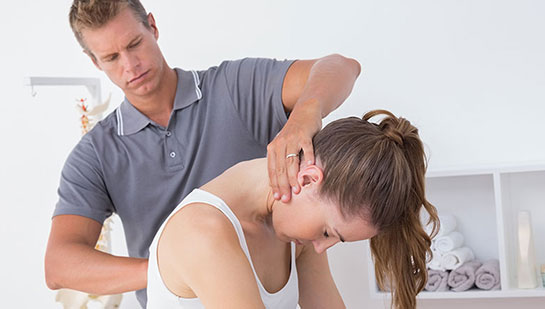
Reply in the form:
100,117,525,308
267,54,361,202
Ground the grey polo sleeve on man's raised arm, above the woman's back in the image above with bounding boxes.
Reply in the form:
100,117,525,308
219,58,295,146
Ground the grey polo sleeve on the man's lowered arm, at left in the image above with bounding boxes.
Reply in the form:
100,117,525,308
53,136,114,224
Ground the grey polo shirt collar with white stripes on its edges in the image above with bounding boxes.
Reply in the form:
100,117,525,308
116,68,202,135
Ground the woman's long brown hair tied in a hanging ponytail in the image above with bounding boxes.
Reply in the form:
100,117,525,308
313,110,439,308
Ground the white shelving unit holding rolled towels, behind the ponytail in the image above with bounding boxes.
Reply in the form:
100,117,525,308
367,162,545,299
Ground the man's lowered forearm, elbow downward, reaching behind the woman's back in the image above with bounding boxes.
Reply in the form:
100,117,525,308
45,244,148,295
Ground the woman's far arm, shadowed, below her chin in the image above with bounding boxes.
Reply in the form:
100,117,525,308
297,245,346,309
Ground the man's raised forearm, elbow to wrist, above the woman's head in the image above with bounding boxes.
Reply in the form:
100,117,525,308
292,54,361,118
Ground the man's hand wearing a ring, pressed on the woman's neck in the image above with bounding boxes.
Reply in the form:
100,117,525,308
267,101,322,203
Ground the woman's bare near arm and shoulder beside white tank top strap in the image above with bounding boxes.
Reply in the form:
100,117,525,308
157,204,265,308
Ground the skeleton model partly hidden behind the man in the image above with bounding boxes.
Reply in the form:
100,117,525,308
56,94,123,309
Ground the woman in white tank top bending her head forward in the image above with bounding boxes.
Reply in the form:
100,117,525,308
147,110,438,309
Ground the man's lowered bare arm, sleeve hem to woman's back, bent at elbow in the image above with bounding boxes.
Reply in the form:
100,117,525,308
45,215,147,295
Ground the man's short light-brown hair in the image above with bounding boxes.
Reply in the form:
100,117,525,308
68,0,150,52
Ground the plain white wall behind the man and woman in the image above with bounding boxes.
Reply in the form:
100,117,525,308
0,0,545,309
